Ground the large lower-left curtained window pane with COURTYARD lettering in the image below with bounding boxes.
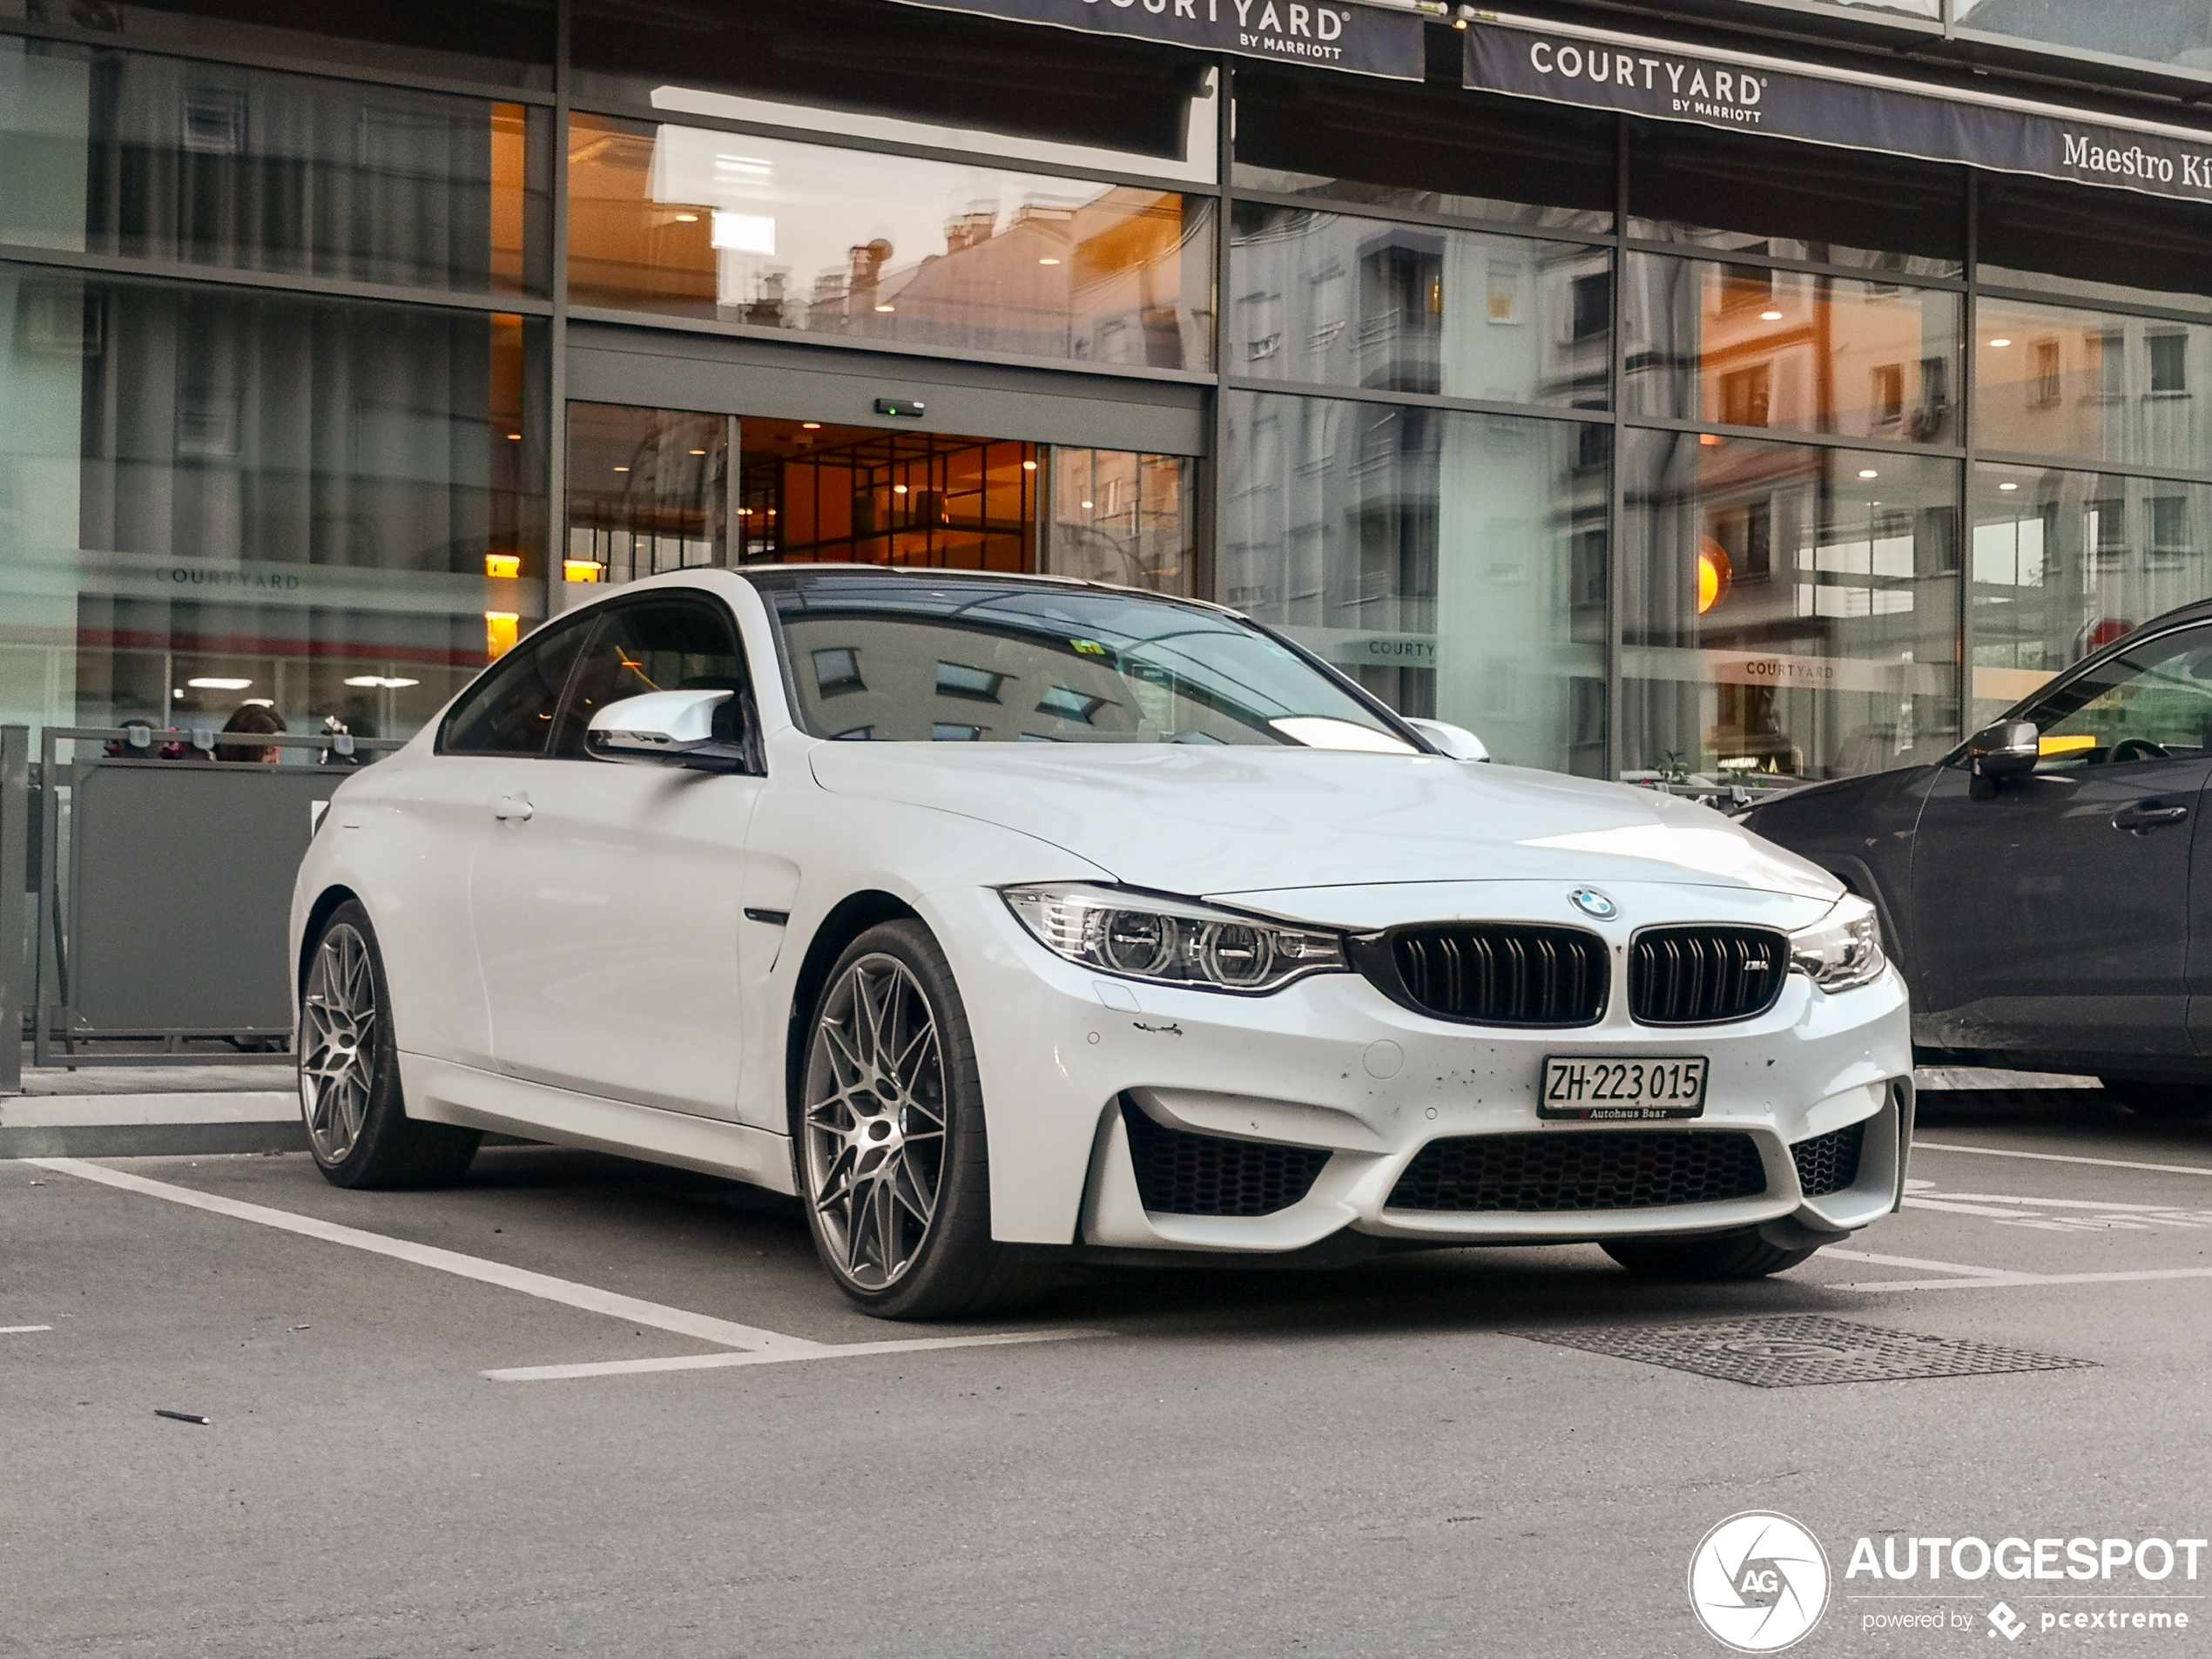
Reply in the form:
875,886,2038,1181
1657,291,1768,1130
0,266,546,759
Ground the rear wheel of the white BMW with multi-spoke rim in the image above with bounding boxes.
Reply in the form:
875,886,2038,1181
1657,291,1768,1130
292,900,484,1188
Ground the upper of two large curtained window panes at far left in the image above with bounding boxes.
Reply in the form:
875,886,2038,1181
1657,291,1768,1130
0,36,544,294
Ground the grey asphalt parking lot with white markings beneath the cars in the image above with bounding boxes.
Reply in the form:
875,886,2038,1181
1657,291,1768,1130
0,1090,2212,1659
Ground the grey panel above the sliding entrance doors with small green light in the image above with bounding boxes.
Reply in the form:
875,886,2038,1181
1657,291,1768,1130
569,323,1208,455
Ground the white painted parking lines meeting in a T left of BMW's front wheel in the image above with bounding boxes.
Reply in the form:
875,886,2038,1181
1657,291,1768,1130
24,1157,1109,1383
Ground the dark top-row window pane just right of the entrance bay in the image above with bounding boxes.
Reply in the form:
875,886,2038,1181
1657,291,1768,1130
1234,66,1615,233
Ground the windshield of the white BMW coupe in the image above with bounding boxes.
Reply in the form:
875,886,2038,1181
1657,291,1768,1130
752,570,1413,754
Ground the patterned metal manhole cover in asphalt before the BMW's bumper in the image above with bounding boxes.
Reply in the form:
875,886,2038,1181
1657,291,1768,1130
1513,1314,2094,1389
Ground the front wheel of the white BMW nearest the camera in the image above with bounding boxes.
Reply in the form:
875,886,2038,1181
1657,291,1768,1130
792,921,1051,1318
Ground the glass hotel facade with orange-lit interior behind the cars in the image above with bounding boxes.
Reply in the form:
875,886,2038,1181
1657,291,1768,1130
0,0,2212,781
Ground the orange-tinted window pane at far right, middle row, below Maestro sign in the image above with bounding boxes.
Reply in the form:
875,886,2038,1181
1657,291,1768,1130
1973,299,2212,471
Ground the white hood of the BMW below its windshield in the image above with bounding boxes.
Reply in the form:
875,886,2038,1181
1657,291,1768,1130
810,741,1843,900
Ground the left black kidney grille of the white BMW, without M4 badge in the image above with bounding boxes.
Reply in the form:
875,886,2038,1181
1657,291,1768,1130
1385,922,1608,1027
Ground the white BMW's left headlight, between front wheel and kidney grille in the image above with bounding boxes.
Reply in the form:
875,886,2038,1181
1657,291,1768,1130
1000,882,1345,991
